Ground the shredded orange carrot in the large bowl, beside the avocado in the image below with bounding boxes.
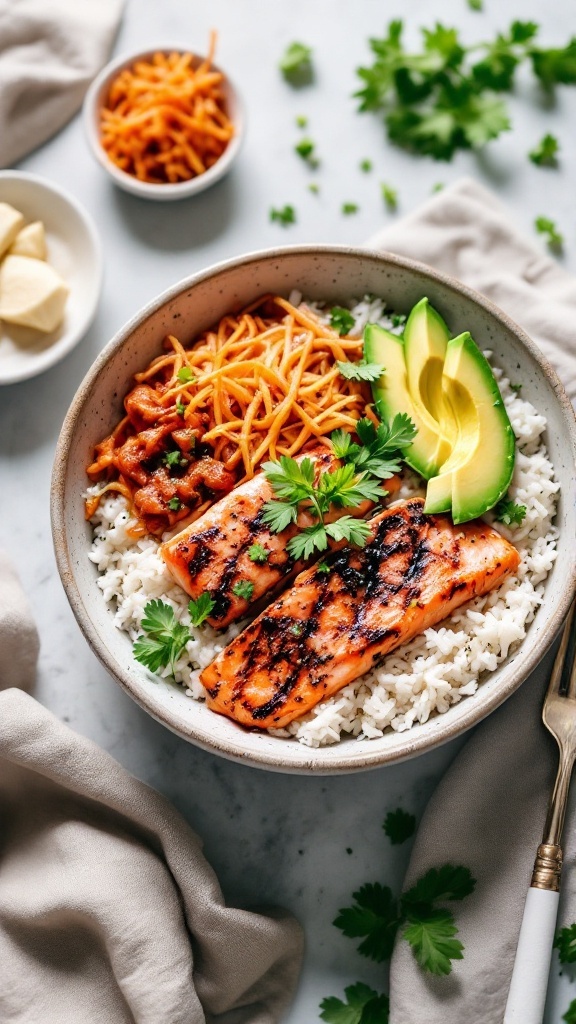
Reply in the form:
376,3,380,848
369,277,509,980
87,295,373,514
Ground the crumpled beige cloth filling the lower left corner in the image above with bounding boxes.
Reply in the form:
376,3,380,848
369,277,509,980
0,559,302,1024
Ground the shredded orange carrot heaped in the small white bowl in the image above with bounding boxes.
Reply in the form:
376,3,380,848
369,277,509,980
100,33,234,184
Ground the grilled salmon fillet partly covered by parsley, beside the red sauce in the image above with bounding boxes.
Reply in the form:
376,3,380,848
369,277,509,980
160,447,399,629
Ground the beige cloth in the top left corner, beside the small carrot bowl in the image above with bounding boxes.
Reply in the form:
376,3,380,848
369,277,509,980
0,0,124,167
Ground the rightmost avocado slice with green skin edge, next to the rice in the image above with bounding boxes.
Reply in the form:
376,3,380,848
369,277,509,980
424,332,516,523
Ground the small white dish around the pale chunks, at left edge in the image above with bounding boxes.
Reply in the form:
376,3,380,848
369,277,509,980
0,171,102,384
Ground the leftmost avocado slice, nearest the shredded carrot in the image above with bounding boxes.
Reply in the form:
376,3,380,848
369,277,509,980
364,324,449,480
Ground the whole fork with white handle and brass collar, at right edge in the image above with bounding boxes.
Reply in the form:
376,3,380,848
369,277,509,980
504,602,576,1024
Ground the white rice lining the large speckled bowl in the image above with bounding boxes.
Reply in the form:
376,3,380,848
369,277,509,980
89,293,560,746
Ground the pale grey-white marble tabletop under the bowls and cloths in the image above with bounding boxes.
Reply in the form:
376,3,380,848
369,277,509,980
0,0,576,1024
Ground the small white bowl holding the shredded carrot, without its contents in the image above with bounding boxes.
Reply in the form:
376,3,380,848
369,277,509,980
83,46,246,202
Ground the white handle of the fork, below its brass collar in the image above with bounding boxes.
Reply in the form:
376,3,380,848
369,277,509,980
504,887,560,1024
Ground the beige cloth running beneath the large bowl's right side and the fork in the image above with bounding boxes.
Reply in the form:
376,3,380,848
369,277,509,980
369,179,576,1024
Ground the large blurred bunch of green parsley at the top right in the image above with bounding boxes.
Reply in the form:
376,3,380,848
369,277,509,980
356,19,576,160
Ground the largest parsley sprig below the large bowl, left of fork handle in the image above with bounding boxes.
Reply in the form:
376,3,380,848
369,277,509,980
334,864,476,975
